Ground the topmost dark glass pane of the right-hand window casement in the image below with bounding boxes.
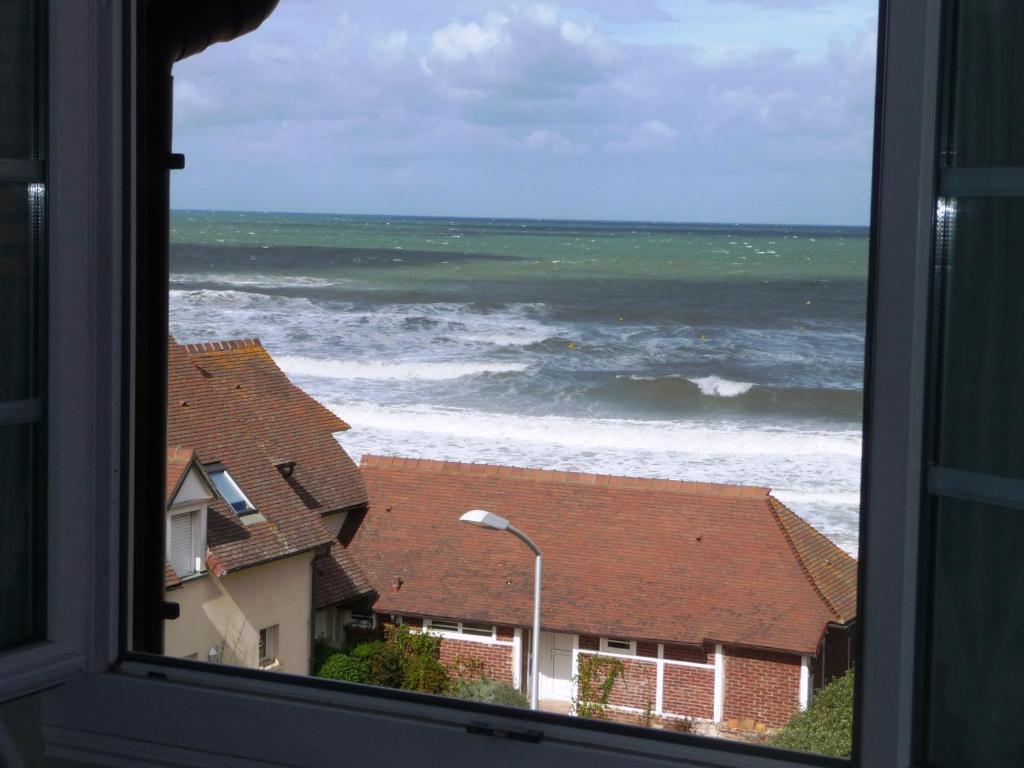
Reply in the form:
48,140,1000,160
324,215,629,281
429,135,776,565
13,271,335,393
950,0,1024,166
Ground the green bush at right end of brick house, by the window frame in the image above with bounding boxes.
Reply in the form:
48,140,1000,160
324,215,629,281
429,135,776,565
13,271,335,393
771,670,853,758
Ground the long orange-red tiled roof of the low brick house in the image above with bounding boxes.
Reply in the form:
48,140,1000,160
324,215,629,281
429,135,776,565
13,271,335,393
348,456,856,653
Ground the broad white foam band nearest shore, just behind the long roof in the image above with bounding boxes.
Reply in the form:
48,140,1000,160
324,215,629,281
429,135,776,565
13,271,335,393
322,398,860,554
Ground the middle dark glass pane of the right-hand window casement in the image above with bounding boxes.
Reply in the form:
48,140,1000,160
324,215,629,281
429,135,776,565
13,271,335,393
937,199,1024,477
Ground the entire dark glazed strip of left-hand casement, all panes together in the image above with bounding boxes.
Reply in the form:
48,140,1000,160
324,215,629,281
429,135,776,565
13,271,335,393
0,0,47,649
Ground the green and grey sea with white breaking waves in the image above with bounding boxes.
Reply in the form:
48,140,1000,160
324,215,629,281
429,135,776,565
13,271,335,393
170,210,867,555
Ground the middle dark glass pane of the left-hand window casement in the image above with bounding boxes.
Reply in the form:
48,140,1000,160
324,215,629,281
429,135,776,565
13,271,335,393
0,183,43,400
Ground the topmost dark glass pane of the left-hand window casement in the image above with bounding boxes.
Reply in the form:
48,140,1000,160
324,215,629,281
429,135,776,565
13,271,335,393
0,0,38,158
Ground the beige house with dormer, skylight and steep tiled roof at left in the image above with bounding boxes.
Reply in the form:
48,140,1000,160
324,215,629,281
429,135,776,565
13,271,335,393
164,339,372,674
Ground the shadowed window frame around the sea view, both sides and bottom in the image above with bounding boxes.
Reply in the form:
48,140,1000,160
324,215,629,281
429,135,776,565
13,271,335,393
16,0,941,768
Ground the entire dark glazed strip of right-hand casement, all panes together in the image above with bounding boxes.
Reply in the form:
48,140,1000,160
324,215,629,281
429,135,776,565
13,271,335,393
923,0,1024,768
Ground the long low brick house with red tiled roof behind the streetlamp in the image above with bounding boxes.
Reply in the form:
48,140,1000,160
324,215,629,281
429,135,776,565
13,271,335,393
341,456,857,727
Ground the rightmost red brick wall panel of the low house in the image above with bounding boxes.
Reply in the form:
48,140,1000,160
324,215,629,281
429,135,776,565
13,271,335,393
724,647,800,728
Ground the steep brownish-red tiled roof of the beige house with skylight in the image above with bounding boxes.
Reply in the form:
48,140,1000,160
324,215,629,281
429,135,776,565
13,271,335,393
167,339,367,593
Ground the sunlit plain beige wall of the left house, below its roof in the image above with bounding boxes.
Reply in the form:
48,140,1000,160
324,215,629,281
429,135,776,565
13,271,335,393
164,552,313,675
